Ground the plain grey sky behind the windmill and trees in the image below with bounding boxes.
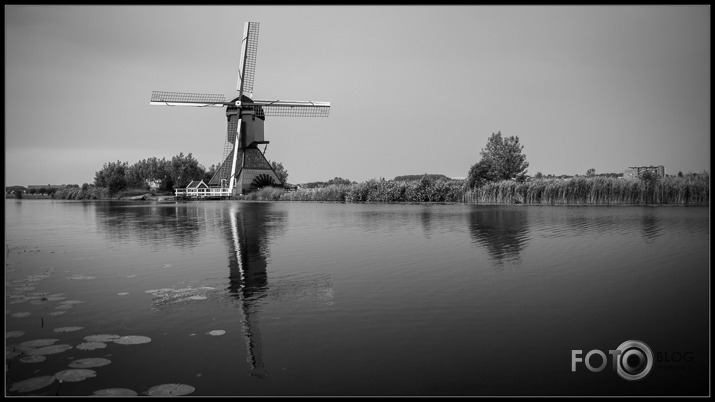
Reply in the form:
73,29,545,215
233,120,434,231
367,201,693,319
5,5,711,185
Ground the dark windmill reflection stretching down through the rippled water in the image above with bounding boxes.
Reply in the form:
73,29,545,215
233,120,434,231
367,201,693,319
224,203,286,378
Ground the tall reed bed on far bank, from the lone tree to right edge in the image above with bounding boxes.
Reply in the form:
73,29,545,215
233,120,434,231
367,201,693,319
464,175,710,205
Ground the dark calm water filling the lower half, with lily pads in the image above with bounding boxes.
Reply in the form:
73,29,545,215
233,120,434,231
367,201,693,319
5,200,710,396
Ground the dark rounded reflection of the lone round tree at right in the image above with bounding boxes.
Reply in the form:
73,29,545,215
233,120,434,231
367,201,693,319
469,206,529,262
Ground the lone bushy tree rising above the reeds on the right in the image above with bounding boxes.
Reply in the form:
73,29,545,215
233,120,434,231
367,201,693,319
465,131,529,188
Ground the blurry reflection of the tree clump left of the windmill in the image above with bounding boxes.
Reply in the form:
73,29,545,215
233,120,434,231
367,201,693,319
96,201,205,248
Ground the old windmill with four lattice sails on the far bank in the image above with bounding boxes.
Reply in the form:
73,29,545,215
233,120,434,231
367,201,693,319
150,22,330,195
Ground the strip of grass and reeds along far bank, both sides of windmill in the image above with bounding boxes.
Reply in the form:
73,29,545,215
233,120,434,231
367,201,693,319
6,175,710,205
